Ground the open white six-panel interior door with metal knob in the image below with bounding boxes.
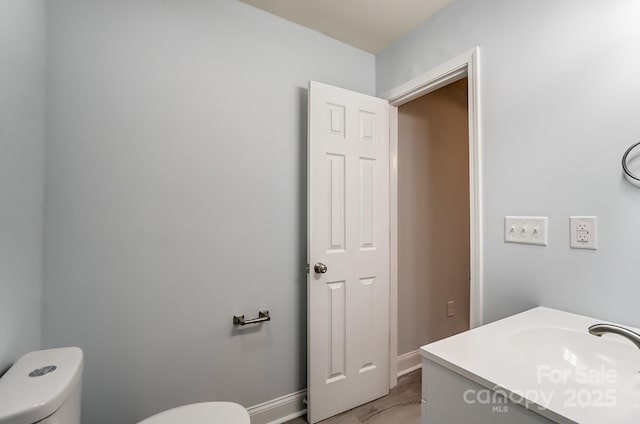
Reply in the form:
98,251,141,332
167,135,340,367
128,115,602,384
307,81,389,423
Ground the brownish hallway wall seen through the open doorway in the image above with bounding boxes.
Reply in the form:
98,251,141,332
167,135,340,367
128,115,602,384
398,78,469,355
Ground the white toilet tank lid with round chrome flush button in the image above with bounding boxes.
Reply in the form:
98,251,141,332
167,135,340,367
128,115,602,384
0,347,83,424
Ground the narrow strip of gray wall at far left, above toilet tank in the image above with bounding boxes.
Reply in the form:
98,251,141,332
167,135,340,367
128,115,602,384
0,0,45,374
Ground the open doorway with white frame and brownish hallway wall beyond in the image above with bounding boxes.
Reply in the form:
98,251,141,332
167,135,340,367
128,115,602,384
383,47,482,387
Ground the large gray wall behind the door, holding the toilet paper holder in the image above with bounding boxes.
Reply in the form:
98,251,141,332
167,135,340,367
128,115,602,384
44,0,375,424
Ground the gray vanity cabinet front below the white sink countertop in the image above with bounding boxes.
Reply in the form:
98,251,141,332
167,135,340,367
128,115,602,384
422,358,555,424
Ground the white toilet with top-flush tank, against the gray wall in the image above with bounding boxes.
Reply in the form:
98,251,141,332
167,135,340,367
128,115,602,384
0,347,251,424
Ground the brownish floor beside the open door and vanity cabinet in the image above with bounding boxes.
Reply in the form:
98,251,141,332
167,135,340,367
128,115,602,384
286,370,422,424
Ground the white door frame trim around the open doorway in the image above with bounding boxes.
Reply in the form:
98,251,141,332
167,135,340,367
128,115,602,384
382,47,483,387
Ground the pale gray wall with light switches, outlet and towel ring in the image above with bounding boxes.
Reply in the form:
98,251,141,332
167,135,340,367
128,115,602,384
376,0,640,326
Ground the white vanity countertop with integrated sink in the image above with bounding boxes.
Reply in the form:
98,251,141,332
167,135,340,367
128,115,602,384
420,307,640,424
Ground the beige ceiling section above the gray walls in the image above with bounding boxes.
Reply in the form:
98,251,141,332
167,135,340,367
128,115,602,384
240,0,454,53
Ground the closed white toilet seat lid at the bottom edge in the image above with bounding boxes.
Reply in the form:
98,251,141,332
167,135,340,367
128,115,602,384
138,402,251,424
